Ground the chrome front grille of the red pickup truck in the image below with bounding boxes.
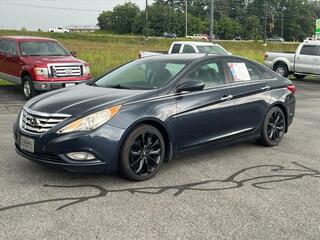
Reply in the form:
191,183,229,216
48,63,83,78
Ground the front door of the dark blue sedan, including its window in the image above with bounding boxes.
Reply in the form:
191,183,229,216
176,59,234,150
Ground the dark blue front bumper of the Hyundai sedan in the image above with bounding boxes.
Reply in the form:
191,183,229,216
14,124,124,173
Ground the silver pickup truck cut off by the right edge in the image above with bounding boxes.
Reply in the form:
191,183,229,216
264,40,320,79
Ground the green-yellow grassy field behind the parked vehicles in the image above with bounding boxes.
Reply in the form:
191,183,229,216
0,30,298,80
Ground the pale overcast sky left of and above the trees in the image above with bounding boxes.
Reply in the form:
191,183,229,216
0,0,152,31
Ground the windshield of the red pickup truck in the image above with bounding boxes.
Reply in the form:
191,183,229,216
20,41,70,56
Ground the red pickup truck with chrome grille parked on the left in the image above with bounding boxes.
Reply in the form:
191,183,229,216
0,36,91,99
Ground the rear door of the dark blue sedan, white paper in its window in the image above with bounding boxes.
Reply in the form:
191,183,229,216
227,58,275,134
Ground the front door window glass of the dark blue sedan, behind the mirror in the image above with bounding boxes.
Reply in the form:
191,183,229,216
186,61,227,88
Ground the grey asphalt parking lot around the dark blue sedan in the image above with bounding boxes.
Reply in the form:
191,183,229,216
0,81,320,240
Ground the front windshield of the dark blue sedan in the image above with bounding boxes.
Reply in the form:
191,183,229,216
93,59,188,90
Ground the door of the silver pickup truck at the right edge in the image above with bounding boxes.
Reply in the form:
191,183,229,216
295,44,318,74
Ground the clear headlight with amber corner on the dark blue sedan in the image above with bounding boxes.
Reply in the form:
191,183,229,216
57,105,121,134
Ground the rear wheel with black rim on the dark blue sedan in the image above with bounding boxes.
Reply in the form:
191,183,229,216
258,107,286,147
